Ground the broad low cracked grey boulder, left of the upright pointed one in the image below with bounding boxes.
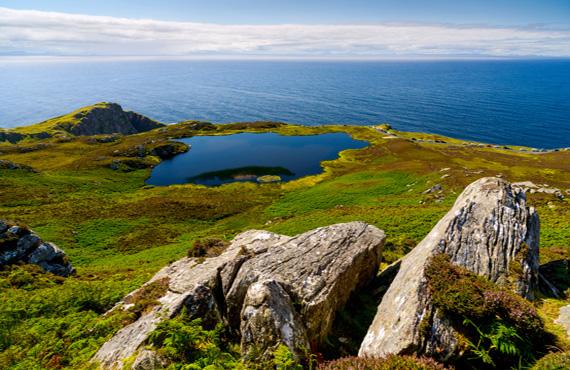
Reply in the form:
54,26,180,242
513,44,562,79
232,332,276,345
94,222,385,369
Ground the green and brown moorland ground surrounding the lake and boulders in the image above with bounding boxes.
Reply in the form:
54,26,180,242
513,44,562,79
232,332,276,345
0,114,570,369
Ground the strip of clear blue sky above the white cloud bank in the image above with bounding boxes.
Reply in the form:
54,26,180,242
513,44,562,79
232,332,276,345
0,0,570,25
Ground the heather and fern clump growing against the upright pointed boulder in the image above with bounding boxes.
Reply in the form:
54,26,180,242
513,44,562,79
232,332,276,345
426,254,552,368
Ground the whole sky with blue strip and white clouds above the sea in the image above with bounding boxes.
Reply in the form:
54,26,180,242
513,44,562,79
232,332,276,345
0,0,570,58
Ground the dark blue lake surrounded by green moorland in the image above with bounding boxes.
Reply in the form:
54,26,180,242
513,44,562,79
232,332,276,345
147,133,368,186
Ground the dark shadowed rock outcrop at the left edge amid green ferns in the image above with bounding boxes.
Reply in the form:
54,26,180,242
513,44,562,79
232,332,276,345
0,220,75,276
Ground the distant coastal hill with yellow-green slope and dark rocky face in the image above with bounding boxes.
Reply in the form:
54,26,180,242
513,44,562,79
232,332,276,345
0,103,164,143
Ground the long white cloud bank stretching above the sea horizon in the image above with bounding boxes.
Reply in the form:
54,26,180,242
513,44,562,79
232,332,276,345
0,8,570,57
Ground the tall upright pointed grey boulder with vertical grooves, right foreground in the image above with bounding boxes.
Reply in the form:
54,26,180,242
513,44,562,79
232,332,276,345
359,178,539,357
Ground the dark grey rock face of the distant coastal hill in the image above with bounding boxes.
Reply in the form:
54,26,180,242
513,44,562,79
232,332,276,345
60,103,163,136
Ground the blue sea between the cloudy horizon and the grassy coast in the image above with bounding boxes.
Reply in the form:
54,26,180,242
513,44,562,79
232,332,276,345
0,60,570,148
